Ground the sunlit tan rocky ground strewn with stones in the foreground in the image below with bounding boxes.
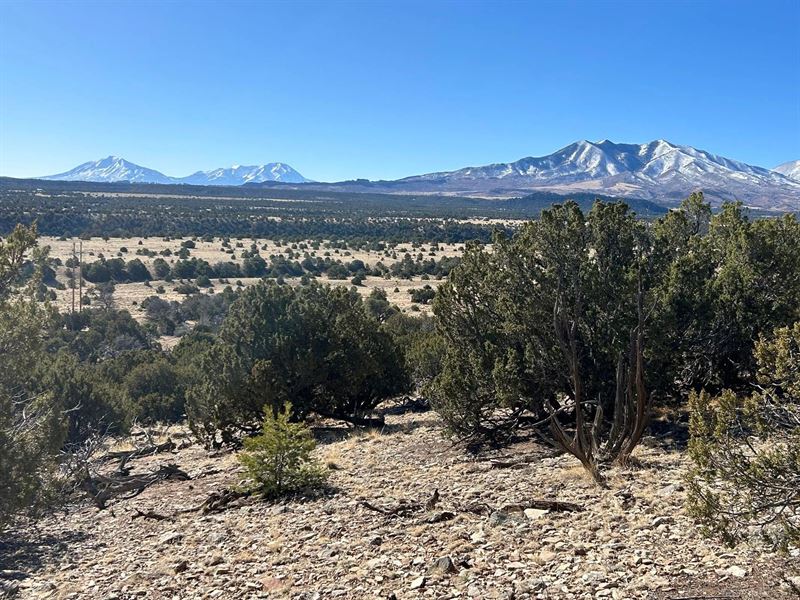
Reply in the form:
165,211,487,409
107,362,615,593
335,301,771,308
0,413,800,600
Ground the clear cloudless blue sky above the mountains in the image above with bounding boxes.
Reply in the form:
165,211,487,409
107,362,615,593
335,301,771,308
0,0,800,180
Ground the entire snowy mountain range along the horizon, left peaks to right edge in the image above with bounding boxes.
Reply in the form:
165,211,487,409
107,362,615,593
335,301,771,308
36,140,800,211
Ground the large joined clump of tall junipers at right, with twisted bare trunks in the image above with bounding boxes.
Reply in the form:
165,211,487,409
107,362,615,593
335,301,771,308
428,194,800,480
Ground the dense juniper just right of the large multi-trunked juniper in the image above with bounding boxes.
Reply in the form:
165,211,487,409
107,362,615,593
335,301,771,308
651,194,800,397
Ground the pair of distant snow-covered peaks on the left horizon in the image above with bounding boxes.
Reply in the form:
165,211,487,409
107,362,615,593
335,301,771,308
39,156,308,185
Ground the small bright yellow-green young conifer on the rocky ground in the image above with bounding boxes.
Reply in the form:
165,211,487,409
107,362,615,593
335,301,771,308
239,403,327,498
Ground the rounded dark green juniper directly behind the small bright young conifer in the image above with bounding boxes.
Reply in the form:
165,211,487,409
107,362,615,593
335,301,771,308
188,282,408,442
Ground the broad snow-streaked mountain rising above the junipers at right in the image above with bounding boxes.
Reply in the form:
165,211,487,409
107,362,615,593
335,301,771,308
394,140,800,210
